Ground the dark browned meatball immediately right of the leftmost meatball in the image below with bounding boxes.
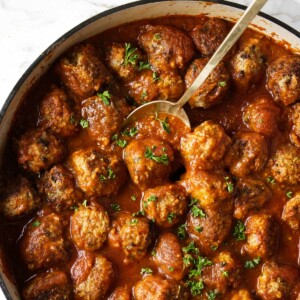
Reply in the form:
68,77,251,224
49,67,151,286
39,165,83,212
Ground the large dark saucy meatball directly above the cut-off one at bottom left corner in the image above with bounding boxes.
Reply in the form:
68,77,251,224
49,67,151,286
20,213,67,270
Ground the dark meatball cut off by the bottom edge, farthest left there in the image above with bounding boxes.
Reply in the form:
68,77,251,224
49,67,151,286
23,271,71,300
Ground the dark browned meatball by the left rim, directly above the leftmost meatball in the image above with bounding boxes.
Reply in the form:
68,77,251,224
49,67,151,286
17,129,64,173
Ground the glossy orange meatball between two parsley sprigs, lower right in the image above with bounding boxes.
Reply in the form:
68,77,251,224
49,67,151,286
243,214,279,258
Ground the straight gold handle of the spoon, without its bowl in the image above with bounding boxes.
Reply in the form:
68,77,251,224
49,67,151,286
175,0,268,107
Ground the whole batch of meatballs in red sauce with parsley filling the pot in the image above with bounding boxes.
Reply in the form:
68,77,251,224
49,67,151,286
1,17,300,300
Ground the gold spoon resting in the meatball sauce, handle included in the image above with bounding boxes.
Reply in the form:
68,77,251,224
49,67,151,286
123,0,268,127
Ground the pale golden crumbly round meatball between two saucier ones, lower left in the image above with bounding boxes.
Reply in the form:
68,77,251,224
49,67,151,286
70,205,110,251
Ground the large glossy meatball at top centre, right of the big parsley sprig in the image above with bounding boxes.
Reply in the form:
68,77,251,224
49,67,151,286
138,25,195,70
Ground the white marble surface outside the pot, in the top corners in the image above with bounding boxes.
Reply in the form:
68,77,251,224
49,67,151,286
0,0,300,300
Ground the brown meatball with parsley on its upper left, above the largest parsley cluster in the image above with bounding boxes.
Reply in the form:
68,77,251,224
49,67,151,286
187,207,232,255
